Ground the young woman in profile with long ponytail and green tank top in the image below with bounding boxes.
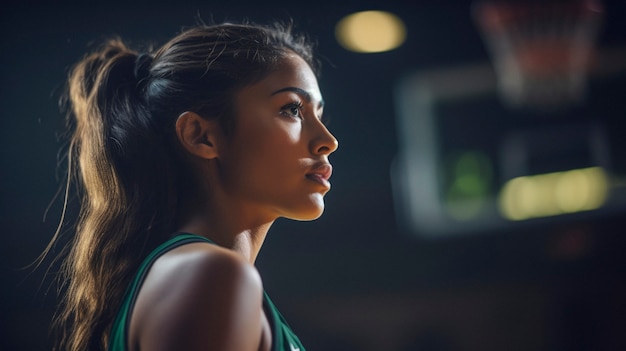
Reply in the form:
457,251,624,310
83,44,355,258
50,24,337,351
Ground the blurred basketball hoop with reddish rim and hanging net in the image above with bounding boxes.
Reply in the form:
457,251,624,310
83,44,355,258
474,0,603,109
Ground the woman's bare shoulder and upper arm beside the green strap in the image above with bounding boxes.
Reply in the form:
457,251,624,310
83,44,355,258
129,243,263,350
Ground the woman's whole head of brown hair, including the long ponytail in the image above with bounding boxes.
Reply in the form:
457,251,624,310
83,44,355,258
50,24,317,350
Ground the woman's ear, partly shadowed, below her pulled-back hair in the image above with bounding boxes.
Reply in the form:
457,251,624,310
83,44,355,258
176,111,221,160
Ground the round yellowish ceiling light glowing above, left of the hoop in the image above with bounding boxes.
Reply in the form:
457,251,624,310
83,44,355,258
335,11,406,53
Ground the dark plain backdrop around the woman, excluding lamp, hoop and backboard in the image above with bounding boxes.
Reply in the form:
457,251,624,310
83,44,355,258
0,0,626,351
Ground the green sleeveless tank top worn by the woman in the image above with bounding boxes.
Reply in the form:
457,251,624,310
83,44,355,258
108,233,304,351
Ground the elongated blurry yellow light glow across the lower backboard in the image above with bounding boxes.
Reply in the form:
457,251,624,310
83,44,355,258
499,167,608,221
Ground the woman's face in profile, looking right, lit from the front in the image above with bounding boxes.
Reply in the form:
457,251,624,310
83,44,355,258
218,54,337,220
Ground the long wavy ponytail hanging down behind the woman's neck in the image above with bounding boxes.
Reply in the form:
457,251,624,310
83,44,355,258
53,40,177,350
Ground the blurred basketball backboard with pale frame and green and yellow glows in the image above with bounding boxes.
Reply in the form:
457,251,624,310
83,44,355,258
392,50,626,236
